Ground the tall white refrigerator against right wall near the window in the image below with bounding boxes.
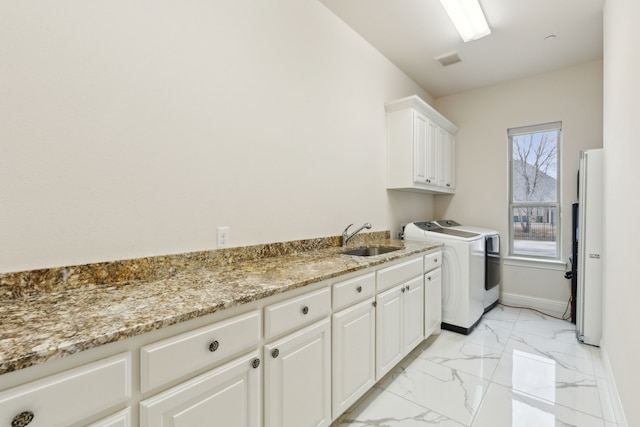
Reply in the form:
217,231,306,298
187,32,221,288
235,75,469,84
576,148,603,346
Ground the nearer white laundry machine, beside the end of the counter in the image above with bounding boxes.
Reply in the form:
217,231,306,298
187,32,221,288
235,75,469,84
404,221,485,334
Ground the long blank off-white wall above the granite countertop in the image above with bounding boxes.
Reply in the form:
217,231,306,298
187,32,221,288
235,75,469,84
0,0,433,272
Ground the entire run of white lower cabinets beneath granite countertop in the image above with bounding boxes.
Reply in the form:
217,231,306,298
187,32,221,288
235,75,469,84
0,251,442,427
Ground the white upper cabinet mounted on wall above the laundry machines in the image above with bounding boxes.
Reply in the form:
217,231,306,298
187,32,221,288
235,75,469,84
385,96,458,194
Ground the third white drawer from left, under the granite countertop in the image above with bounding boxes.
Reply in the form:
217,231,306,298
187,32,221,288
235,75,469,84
264,288,331,338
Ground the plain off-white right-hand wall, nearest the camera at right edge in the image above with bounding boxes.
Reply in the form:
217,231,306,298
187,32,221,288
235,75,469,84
602,0,640,426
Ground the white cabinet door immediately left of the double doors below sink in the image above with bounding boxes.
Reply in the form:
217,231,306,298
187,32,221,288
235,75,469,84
332,298,376,419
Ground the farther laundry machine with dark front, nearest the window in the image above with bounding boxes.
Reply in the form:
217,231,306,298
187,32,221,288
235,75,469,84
434,219,501,313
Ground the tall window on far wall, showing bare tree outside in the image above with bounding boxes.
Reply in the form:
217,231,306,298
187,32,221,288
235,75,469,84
507,122,562,259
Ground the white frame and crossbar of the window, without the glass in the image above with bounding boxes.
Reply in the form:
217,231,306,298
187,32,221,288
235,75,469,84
507,121,563,261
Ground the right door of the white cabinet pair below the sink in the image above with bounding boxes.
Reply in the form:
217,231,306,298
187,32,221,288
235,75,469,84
403,275,424,355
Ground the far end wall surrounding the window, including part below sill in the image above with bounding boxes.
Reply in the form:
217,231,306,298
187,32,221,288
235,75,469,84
435,61,602,310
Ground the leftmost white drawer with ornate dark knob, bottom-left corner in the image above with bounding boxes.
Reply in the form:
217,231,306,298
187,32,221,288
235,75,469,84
0,353,131,427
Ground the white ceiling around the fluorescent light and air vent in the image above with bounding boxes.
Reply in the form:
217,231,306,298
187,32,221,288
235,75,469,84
320,0,605,98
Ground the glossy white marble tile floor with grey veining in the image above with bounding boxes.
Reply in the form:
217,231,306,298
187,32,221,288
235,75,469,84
335,305,617,427
